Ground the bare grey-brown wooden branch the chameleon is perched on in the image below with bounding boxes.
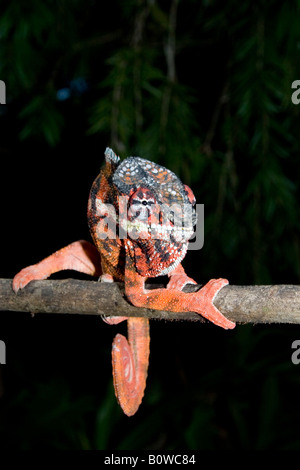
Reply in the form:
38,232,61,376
0,279,300,323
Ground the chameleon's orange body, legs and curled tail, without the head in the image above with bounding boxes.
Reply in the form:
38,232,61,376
13,149,235,416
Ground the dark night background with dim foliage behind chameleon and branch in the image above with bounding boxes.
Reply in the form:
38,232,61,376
0,0,300,450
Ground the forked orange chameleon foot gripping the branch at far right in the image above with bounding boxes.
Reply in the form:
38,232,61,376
190,279,235,330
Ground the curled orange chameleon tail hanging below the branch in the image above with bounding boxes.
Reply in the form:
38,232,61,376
112,317,150,416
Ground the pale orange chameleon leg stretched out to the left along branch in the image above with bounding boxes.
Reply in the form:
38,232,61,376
13,240,101,292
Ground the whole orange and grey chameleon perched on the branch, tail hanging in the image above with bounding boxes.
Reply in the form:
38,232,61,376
13,148,235,416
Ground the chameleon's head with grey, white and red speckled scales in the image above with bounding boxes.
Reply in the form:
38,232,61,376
112,157,196,277
